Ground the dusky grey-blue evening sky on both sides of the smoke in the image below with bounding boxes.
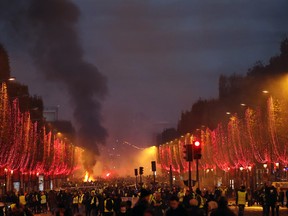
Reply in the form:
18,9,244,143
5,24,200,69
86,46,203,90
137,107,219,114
0,0,288,146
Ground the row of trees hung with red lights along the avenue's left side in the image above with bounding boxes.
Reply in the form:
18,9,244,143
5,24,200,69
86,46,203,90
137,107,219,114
0,83,81,175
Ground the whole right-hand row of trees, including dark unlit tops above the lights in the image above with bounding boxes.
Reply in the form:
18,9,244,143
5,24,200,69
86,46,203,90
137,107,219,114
158,38,288,172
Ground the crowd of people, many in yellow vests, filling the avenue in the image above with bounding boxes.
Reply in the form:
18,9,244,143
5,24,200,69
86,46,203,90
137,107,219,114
0,181,288,216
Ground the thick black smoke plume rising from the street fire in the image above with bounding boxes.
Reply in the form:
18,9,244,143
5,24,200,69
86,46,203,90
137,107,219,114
0,0,107,172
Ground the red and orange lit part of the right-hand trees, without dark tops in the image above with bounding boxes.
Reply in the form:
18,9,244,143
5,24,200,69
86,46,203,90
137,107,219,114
158,93,288,173
